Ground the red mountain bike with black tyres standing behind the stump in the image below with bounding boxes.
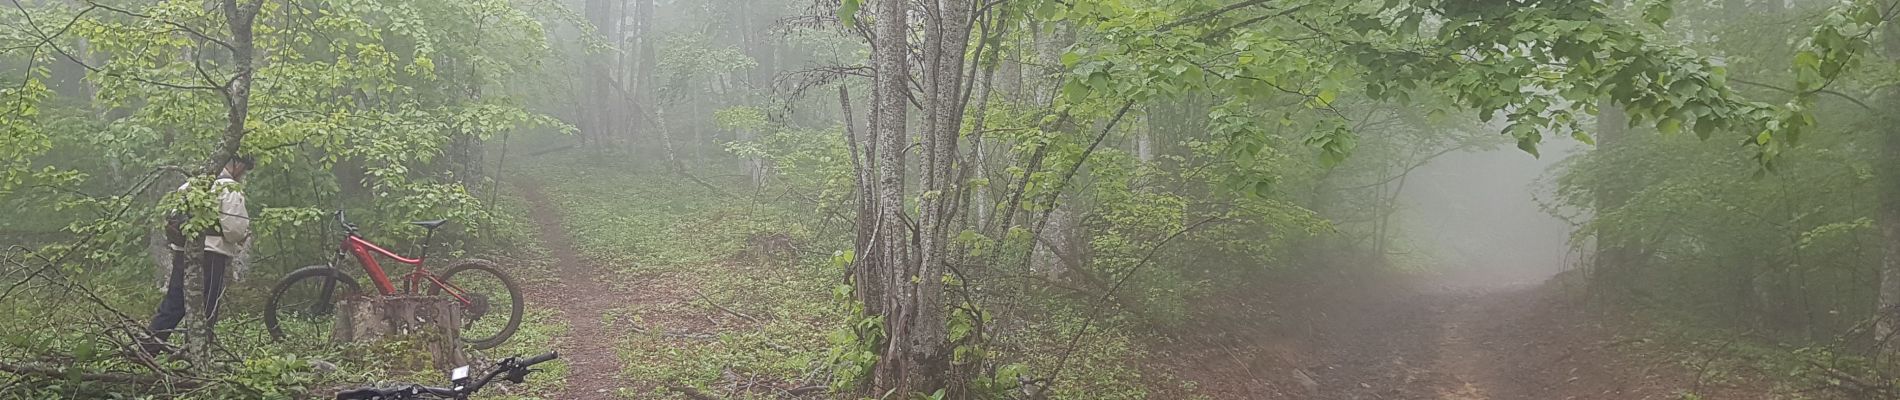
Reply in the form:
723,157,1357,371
264,210,523,349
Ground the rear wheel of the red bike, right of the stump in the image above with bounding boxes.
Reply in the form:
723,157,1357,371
429,260,524,349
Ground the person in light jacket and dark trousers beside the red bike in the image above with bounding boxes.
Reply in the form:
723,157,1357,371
152,155,255,350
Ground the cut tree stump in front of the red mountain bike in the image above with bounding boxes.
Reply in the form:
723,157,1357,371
331,296,467,372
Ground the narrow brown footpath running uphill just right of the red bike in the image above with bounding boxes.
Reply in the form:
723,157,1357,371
521,182,625,398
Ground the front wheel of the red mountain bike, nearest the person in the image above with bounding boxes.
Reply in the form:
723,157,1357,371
264,265,363,343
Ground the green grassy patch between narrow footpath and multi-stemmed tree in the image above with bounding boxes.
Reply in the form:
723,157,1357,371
532,159,844,398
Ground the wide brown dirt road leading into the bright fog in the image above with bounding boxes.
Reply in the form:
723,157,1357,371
1157,271,1777,400
